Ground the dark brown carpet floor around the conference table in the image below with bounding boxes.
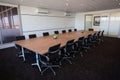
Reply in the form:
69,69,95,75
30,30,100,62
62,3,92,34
0,37,120,80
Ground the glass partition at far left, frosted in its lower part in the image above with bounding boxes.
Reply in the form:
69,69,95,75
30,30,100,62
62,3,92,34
0,6,20,43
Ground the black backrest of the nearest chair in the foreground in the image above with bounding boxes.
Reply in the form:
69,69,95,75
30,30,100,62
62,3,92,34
48,44,60,62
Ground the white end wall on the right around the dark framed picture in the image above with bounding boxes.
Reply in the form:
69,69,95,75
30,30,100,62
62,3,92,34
75,9,120,37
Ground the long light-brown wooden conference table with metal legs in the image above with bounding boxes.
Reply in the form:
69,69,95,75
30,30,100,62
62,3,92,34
15,31,96,71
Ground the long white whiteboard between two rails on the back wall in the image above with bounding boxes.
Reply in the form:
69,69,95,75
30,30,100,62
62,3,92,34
21,15,75,31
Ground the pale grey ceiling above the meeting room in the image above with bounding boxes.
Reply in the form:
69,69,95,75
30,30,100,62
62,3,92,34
0,0,120,12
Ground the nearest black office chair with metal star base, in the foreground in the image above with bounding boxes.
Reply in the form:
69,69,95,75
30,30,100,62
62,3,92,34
41,44,61,75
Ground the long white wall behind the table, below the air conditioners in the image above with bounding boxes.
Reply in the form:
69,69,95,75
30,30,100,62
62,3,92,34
20,6,75,38
